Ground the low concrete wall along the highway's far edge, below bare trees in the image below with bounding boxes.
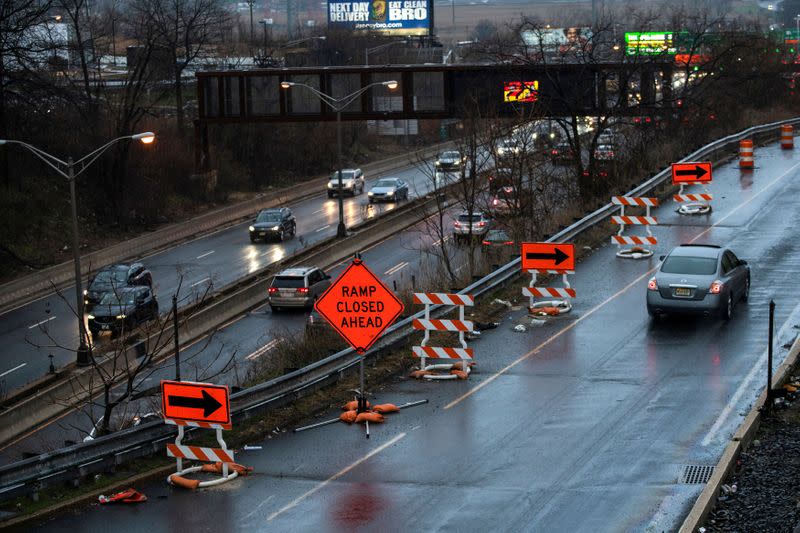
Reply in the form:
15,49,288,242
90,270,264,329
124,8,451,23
0,142,452,314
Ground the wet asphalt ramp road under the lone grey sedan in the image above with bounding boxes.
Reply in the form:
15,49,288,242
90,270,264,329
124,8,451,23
18,139,800,532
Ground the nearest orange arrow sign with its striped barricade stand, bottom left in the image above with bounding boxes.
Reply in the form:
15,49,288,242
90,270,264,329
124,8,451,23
156,381,244,489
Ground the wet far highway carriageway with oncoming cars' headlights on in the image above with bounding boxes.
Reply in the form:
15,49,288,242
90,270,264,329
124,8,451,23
0,156,456,392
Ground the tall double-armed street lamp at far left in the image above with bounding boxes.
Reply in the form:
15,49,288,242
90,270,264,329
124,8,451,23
0,131,156,366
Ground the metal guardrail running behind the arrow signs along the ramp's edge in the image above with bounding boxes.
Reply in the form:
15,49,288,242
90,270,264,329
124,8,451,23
0,118,800,500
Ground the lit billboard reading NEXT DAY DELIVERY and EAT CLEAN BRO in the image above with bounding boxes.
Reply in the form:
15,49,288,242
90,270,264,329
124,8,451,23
328,0,431,35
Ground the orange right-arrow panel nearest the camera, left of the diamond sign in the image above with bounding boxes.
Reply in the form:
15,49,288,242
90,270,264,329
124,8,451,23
161,381,231,425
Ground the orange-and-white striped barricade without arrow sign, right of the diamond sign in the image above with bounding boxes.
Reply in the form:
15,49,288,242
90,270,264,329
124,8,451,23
411,292,475,380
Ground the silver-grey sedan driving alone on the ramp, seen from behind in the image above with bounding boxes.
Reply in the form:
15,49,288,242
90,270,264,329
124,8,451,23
647,244,750,320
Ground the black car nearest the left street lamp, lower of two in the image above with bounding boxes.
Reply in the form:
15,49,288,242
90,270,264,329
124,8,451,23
88,287,158,338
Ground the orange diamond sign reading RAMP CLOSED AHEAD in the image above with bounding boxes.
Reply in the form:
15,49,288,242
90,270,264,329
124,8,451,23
314,259,403,353
